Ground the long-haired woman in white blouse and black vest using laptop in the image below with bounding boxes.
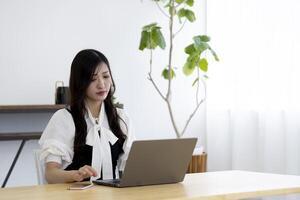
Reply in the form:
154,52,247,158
39,49,134,183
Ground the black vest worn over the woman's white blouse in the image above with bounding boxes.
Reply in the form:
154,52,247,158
65,109,124,181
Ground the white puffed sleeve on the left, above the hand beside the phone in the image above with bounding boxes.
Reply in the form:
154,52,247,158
39,109,75,168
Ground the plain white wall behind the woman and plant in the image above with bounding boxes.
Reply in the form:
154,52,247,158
0,0,205,188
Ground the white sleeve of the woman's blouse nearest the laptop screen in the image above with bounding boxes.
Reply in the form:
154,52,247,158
118,109,135,171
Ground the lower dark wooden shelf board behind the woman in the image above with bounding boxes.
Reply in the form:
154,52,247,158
0,132,42,141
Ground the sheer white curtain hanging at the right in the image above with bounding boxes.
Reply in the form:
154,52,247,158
207,0,300,199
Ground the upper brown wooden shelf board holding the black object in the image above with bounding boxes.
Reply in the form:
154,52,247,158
0,104,66,113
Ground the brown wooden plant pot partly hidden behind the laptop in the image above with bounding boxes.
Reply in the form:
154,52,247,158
187,152,207,173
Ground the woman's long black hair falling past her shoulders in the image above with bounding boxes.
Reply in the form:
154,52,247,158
69,49,126,153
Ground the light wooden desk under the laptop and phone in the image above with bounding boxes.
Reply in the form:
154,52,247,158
0,171,300,200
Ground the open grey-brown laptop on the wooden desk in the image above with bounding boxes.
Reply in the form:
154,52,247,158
93,138,197,187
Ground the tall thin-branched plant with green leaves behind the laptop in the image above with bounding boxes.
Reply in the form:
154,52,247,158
139,0,219,172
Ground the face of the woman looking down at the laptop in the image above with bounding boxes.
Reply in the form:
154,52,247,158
86,62,112,102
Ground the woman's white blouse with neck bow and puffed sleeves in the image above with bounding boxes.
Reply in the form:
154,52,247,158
39,104,135,180
